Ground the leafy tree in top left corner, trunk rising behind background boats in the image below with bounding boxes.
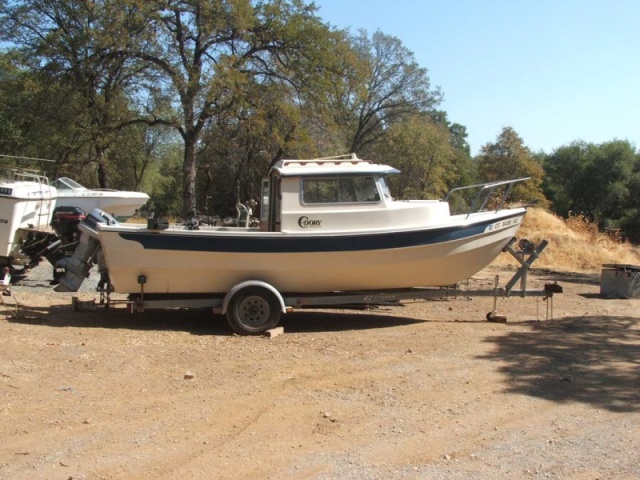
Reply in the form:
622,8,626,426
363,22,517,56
0,0,151,188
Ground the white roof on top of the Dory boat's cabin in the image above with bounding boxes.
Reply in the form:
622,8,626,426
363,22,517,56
269,153,400,177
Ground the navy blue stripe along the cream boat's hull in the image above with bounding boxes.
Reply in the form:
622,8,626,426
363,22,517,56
118,213,522,253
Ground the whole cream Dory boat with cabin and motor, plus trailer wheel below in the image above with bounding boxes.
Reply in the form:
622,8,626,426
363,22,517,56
57,155,527,333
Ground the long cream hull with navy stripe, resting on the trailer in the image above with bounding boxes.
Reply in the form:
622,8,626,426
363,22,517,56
99,208,526,294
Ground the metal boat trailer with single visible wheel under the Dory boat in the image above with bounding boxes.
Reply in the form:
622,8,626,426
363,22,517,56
72,238,562,335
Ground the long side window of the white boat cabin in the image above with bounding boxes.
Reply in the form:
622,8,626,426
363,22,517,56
302,176,380,204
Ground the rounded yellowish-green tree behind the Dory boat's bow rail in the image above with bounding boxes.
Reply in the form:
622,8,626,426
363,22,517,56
476,127,548,207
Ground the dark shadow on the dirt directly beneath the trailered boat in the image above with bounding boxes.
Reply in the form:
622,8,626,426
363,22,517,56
7,305,421,335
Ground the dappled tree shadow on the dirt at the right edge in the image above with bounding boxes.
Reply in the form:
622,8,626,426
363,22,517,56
480,316,640,412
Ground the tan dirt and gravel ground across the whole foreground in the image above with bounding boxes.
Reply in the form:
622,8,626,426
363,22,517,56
0,268,640,480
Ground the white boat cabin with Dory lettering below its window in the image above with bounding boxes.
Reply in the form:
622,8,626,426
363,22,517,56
260,154,449,234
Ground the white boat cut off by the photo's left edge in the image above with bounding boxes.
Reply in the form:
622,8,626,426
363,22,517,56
0,168,57,267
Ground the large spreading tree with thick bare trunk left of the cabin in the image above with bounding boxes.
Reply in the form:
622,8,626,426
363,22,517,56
124,0,336,213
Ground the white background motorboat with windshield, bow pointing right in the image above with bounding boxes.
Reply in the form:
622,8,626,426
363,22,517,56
51,177,149,221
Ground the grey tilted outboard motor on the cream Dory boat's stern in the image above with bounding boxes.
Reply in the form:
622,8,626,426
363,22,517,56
55,208,117,292
